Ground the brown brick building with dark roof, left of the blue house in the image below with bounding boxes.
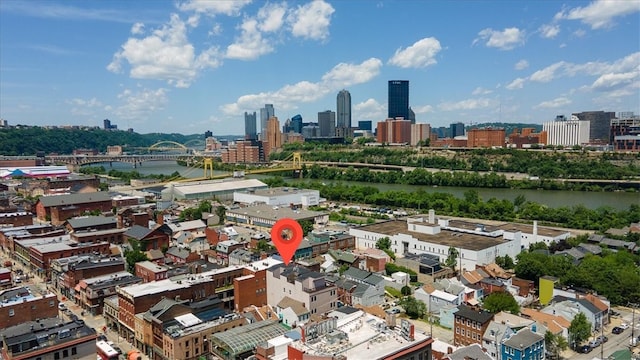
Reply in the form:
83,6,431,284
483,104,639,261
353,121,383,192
453,305,493,346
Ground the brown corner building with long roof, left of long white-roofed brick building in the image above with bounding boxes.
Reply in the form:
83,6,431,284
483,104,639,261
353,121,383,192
74,271,142,316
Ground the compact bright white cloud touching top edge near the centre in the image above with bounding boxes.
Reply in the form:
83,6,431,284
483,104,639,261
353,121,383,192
287,0,335,40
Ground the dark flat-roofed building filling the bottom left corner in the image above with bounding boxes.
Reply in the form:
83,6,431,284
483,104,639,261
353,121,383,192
0,317,96,360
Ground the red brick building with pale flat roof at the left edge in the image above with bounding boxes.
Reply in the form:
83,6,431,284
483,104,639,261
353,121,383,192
0,286,58,329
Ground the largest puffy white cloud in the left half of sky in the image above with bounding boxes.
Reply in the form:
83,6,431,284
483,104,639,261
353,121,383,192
107,14,221,87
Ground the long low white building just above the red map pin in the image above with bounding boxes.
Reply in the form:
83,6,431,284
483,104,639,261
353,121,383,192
233,187,320,207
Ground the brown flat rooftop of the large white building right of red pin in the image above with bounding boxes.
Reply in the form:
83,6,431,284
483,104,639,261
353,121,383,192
354,220,506,251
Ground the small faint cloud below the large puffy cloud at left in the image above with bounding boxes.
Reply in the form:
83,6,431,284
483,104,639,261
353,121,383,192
115,88,168,120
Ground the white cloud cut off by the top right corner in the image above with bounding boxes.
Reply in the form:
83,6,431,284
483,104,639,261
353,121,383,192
555,0,640,29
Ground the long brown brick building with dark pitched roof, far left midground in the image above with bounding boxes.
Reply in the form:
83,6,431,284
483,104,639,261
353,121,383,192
35,192,111,225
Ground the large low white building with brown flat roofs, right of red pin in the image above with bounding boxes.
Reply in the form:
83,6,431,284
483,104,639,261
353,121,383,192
349,210,521,271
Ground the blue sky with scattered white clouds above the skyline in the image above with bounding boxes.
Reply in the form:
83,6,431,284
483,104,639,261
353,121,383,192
0,0,640,136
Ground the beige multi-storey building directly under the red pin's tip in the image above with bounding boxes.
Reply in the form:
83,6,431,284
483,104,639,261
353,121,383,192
267,264,338,315
